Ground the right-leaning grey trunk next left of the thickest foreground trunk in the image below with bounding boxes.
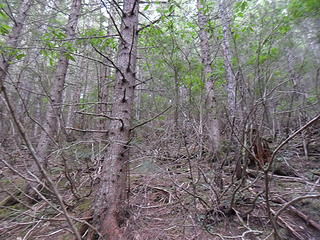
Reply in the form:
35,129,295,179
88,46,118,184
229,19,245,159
27,0,81,192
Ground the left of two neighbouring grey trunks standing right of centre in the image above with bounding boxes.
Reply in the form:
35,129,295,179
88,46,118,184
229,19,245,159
197,0,220,154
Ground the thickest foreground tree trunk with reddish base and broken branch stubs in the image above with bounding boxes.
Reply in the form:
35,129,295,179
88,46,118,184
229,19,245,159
92,0,139,240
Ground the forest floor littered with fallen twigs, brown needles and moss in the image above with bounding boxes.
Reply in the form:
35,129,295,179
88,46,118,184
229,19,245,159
0,126,320,240
